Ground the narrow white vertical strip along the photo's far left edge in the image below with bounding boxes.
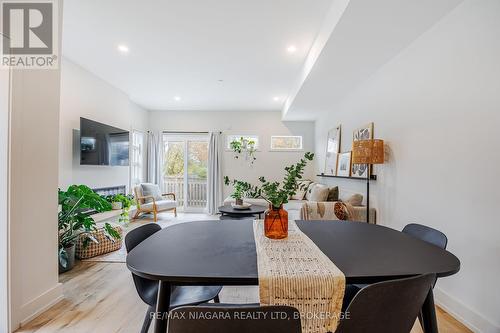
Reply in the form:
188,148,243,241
0,70,10,333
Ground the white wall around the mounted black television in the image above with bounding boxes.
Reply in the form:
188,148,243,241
59,58,147,188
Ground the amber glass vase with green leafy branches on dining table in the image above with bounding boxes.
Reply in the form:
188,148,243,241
259,152,314,239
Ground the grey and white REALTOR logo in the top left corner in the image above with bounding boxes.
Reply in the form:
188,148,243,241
1,0,58,69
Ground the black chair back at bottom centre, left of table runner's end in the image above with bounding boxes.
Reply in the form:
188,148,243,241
167,304,301,333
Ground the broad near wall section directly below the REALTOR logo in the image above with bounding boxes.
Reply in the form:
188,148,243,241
10,70,62,329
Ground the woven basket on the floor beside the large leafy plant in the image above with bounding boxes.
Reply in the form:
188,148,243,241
75,225,123,259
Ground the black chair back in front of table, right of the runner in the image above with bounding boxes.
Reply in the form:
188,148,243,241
335,274,434,333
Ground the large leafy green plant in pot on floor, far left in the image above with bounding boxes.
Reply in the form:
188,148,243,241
58,185,120,273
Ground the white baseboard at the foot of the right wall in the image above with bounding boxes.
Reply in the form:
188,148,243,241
434,287,500,333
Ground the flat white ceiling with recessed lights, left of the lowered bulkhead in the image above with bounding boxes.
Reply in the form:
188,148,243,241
63,0,332,111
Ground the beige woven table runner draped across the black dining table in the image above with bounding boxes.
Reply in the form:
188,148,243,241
254,220,345,333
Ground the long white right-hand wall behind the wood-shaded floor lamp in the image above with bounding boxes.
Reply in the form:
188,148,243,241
316,0,500,332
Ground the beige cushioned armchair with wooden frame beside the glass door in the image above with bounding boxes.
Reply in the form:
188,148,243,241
133,184,177,222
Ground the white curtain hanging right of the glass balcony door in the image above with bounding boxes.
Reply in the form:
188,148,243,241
207,132,223,215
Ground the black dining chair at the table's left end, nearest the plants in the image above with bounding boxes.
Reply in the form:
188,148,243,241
125,223,222,333
